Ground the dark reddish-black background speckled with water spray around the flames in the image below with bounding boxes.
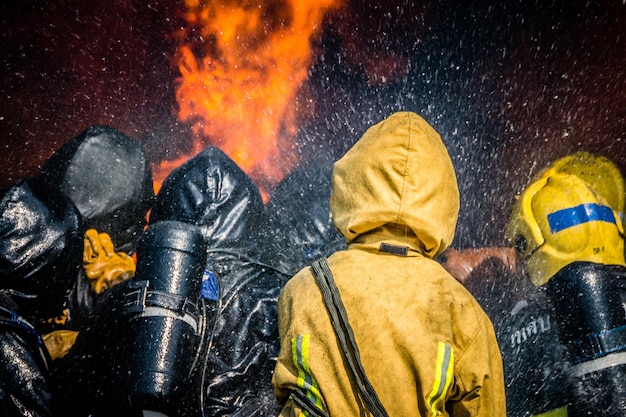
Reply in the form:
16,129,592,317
0,0,626,248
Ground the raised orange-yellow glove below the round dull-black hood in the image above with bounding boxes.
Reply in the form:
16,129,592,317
83,229,135,294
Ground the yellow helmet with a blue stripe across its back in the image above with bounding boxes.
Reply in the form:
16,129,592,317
507,173,626,286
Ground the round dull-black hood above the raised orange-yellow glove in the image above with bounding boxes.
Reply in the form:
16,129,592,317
40,126,154,253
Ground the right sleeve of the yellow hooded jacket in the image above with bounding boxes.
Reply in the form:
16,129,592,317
448,313,506,417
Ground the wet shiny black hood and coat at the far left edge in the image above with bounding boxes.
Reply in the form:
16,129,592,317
0,178,84,417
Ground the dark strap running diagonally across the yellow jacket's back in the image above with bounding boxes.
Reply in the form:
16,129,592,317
311,258,388,417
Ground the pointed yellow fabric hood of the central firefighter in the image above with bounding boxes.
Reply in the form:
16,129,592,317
330,112,460,258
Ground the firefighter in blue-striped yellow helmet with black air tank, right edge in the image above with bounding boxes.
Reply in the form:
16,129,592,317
507,169,626,416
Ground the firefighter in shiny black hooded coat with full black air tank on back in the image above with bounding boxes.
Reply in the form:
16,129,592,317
61,147,287,417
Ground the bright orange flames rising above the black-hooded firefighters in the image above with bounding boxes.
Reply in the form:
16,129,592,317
155,0,343,198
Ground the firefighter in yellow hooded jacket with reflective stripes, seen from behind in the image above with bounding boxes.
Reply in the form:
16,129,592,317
272,112,506,417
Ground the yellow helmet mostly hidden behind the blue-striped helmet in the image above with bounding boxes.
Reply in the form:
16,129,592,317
537,151,626,224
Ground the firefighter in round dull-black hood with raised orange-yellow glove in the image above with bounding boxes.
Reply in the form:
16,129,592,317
39,125,154,331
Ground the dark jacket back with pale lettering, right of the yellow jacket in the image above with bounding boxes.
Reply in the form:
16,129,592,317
465,259,572,417
